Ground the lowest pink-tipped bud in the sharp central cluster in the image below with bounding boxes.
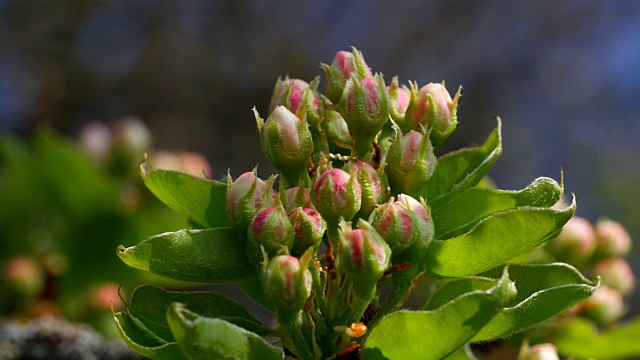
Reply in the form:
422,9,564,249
262,255,311,316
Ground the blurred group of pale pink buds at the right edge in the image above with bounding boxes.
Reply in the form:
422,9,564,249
545,216,635,325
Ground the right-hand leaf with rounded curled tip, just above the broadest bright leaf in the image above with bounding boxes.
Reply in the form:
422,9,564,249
431,177,563,240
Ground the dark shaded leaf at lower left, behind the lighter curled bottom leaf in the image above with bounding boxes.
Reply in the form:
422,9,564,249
128,285,274,342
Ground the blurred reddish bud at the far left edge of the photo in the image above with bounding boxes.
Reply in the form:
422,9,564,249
4,257,45,300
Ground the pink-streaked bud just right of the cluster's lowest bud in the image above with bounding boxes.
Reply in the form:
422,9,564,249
340,219,391,299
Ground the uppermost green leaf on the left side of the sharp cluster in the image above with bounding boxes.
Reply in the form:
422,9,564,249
140,162,231,228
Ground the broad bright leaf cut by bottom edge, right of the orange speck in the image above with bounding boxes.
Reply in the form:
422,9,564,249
362,271,515,360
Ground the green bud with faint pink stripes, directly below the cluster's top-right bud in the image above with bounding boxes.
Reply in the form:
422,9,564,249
386,130,437,195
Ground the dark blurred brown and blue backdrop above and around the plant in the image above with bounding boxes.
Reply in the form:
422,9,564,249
0,0,640,346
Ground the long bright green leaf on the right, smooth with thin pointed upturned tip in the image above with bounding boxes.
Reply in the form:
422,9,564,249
426,199,576,277
